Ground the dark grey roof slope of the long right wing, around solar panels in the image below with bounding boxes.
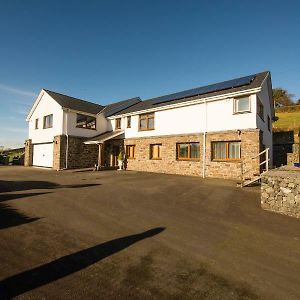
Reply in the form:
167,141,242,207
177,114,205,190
112,71,270,115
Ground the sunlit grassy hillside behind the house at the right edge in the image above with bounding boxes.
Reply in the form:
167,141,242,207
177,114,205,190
273,105,300,131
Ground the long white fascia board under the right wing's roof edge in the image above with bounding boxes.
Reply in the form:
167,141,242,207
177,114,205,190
107,87,261,120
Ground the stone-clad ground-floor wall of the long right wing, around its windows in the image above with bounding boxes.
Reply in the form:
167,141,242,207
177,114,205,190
125,129,261,179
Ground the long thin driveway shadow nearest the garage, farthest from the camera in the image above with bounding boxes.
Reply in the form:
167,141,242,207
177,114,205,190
0,180,101,193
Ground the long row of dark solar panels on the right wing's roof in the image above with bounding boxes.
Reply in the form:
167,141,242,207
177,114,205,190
152,75,255,105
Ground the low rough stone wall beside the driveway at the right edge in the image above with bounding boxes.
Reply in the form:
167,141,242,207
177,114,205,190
261,167,300,218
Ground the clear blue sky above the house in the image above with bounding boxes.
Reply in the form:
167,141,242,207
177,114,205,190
0,0,300,147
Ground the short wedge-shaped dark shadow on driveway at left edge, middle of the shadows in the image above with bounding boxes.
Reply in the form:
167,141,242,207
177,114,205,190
0,203,39,231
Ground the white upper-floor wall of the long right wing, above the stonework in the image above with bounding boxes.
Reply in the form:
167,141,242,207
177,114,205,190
121,95,256,138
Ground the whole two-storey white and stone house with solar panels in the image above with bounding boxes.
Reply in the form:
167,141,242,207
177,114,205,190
25,72,274,182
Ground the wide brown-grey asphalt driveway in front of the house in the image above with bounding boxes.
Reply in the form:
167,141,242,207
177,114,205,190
0,167,300,299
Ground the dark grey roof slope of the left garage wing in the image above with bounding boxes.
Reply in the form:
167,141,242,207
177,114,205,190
44,89,104,114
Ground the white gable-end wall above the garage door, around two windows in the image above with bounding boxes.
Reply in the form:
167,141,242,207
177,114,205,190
28,93,63,144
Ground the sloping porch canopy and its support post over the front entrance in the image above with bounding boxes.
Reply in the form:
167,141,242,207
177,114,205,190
84,130,125,170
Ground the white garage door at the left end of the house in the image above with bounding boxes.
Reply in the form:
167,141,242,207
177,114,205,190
32,143,53,168
